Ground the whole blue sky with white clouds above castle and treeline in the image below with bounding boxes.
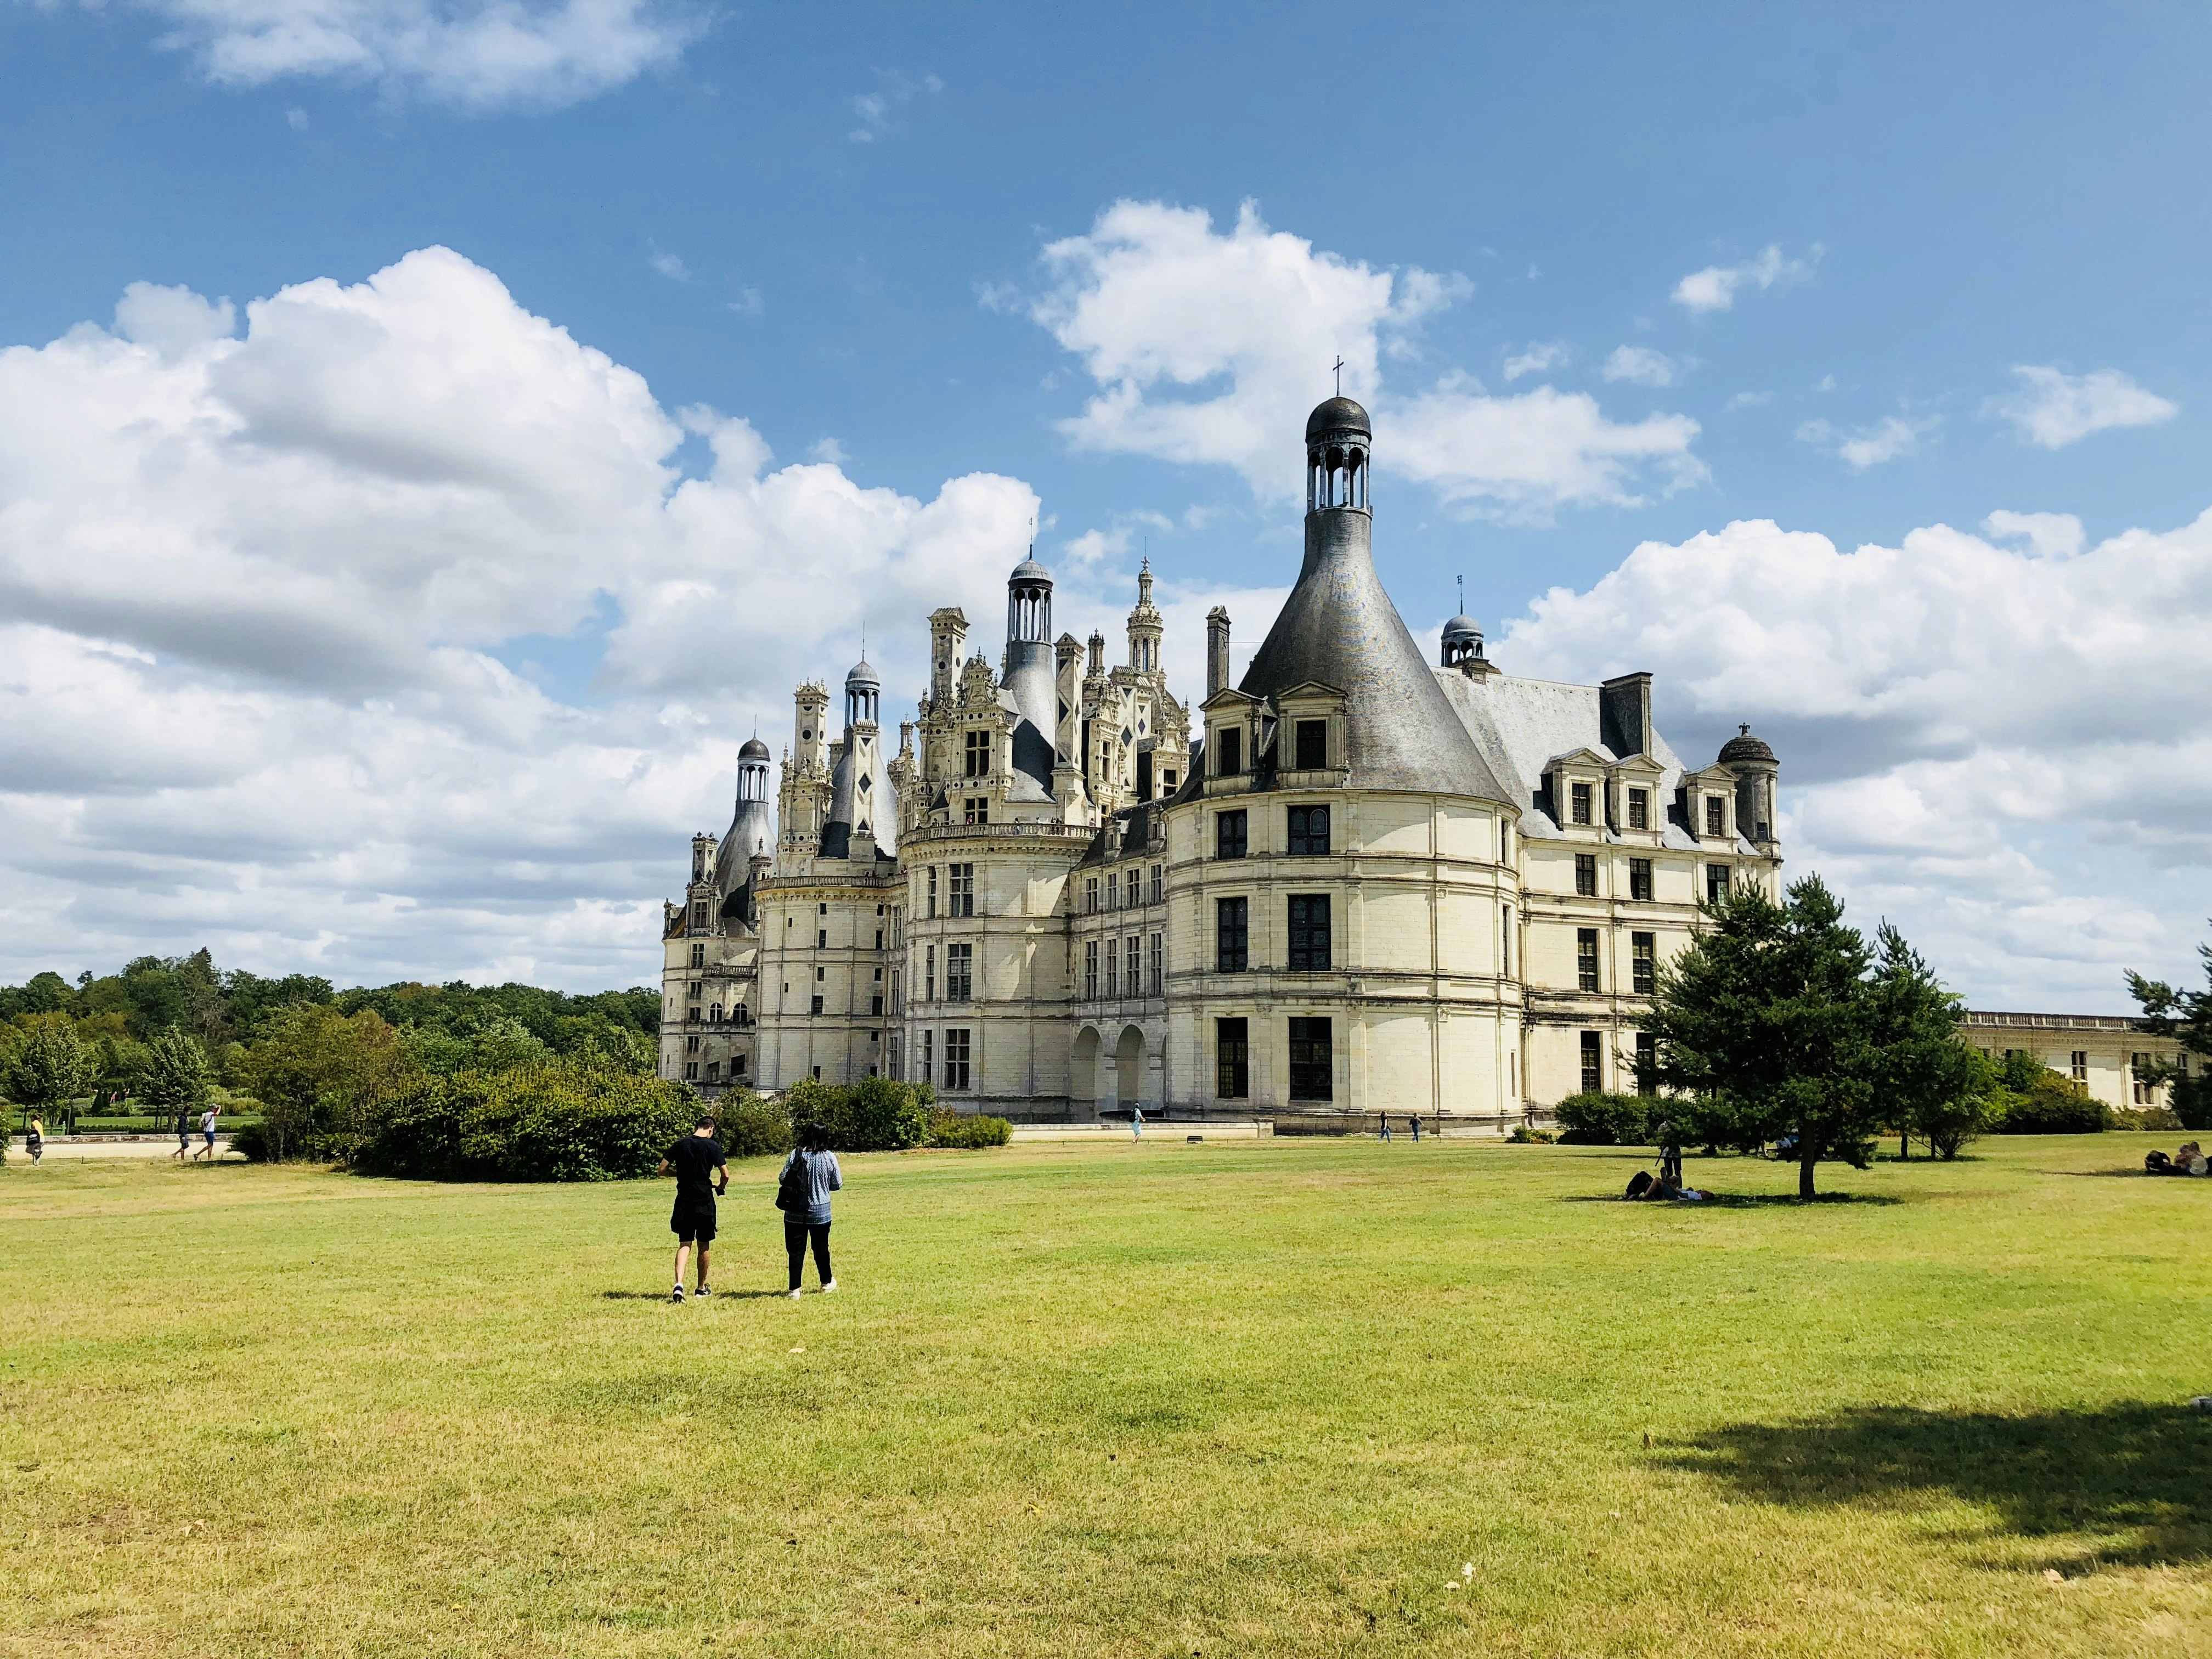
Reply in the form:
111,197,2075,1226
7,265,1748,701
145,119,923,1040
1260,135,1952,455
0,0,2212,1009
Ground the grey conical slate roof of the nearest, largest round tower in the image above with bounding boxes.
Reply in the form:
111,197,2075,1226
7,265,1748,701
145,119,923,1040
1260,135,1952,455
1239,513,1506,801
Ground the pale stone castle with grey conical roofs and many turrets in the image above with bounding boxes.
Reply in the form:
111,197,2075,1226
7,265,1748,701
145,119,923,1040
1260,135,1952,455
662,396,1781,1130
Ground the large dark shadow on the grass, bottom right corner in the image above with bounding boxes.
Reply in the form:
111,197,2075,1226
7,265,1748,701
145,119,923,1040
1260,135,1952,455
1663,1400,2212,1566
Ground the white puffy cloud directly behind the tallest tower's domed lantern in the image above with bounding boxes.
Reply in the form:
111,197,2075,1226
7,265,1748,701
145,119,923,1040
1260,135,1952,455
1031,201,1706,517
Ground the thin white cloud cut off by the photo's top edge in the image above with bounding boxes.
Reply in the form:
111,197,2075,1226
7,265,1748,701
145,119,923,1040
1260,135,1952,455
82,0,706,110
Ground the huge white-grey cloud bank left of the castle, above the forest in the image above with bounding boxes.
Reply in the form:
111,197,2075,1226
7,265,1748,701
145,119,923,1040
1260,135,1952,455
0,248,1037,986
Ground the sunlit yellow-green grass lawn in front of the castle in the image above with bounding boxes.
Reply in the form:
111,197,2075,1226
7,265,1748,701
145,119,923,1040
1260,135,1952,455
0,1135,2212,1659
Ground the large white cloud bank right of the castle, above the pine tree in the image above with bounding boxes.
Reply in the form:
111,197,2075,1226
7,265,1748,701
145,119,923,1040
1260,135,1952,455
1491,511,2212,1011
